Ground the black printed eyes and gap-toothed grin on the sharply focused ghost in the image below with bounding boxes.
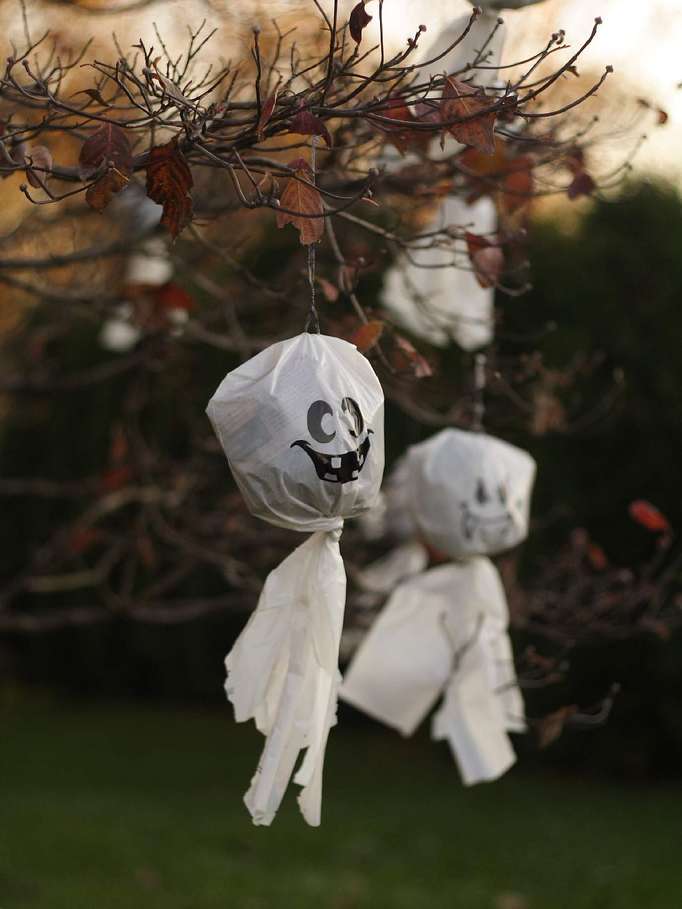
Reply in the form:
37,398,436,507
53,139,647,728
291,397,372,483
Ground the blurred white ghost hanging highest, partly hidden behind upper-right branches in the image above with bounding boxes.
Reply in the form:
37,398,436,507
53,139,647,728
381,0,538,351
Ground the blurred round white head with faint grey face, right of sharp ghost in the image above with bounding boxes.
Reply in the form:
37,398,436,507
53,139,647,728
407,429,535,558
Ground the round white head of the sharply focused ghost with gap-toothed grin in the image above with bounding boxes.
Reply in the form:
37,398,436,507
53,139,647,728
207,334,384,530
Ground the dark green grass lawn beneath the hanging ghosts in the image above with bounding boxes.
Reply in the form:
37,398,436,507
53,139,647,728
0,701,682,909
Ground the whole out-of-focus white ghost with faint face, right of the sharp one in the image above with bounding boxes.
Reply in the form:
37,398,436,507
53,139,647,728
340,429,535,785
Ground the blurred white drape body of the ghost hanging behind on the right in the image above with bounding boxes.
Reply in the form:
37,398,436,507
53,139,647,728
340,557,523,785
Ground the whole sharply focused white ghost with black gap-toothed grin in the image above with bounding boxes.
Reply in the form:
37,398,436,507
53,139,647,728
207,333,384,826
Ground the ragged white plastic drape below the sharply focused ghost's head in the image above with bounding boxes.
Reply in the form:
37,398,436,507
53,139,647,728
225,530,346,826
